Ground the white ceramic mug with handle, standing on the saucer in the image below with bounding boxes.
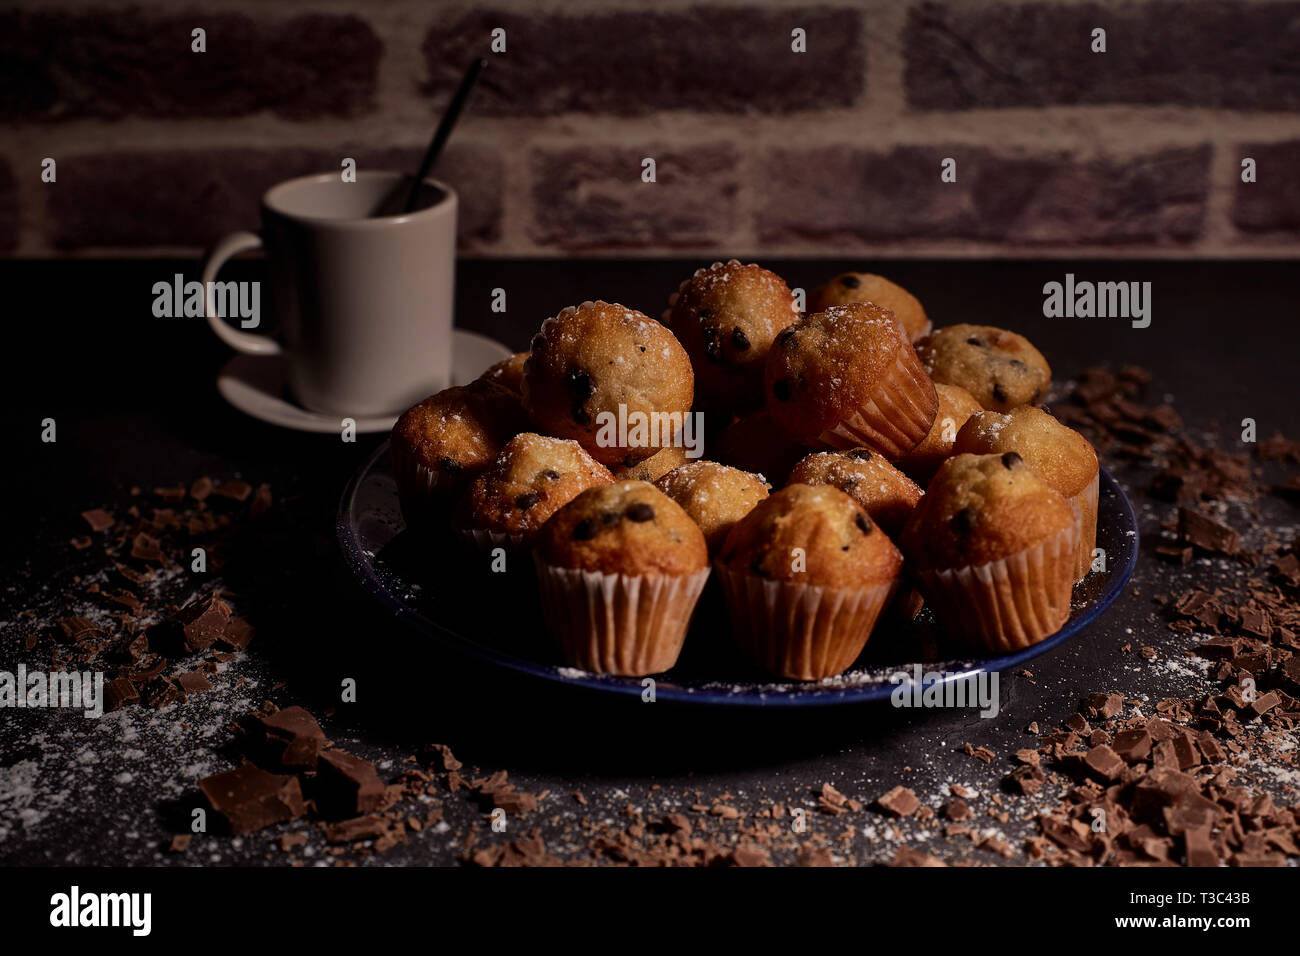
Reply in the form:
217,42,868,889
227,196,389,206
203,172,456,418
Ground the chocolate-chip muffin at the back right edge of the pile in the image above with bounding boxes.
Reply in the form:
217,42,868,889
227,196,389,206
917,324,1052,411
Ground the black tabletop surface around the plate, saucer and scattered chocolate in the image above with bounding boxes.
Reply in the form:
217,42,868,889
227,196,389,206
0,260,1300,864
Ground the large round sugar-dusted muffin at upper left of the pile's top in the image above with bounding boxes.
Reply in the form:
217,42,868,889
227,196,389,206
523,302,694,466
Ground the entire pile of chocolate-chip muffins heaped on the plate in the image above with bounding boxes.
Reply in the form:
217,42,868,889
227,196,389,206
391,260,1097,680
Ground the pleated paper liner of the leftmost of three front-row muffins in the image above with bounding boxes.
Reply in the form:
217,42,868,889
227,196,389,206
536,558,709,678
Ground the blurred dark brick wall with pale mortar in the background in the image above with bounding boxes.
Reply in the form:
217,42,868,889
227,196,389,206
0,0,1300,258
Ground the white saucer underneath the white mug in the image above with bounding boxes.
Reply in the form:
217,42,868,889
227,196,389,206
217,329,514,433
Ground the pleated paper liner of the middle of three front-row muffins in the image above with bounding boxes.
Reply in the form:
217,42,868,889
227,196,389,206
716,562,897,680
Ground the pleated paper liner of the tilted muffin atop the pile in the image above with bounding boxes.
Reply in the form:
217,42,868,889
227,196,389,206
814,349,939,460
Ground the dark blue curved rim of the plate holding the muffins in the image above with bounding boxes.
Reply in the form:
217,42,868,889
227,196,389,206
335,440,1141,708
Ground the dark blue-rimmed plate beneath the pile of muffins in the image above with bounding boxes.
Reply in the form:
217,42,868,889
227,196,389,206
337,442,1138,706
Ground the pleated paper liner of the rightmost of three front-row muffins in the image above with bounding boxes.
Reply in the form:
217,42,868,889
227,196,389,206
914,515,1080,653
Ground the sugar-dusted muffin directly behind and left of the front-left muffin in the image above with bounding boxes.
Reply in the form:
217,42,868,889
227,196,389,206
452,432,614,550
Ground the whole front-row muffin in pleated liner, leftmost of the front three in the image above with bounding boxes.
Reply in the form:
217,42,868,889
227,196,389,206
533,481,709,678
